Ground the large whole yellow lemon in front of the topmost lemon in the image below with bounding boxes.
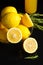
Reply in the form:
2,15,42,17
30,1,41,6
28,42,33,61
1,12,21,28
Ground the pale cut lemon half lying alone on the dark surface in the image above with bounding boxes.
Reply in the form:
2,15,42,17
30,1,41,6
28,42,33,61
23,37,38,54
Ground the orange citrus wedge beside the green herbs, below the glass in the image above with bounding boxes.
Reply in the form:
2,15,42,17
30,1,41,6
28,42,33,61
21,13,33,27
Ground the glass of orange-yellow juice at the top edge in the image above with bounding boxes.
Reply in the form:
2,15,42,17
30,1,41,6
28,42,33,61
25,0,37,14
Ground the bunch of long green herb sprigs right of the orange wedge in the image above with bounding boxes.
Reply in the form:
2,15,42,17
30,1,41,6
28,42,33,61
30,13,43,31
